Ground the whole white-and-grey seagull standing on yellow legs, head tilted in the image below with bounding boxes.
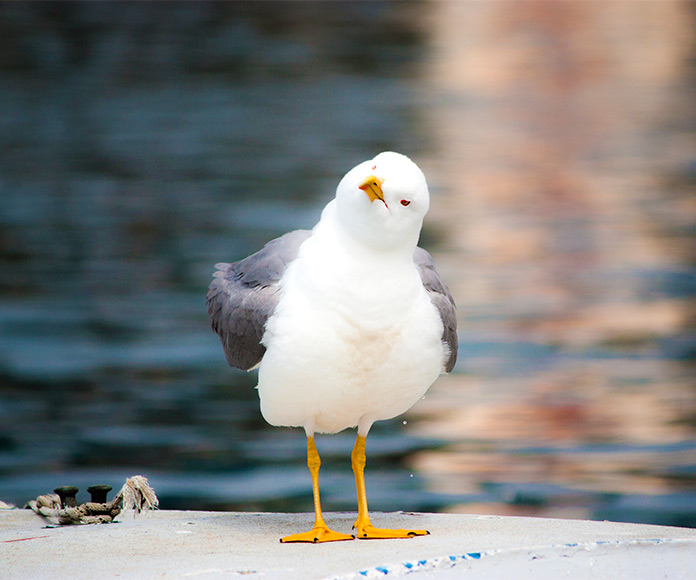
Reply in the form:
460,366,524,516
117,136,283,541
207,151,457,543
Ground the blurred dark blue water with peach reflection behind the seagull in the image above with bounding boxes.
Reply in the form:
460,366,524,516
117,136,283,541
0,0,696,526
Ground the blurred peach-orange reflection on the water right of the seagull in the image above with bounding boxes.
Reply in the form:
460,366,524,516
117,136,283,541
410,1,696,525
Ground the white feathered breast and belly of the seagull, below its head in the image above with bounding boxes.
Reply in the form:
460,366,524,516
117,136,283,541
258,206,446,432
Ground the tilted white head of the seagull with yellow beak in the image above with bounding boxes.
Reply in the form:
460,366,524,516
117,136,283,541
336,151,430,251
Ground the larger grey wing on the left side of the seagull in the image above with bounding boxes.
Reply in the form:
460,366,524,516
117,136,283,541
206,230,311,370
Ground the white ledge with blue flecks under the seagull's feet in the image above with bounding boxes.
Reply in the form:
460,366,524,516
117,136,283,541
0,510,696,580
